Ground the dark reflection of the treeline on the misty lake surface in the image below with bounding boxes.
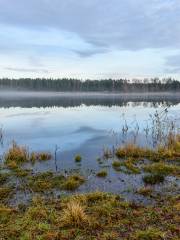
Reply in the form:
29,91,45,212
0,97,180,108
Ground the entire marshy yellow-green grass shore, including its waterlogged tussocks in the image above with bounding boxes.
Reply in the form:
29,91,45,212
0,129,180,240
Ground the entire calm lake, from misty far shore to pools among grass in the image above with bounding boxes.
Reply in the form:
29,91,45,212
0,92,180,203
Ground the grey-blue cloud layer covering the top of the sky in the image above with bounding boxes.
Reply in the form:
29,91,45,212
0,0,180,50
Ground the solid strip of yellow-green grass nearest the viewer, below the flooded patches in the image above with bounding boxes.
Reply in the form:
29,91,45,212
0,192,179,240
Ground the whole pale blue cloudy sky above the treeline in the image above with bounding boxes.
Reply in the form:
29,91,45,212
0,0,180,80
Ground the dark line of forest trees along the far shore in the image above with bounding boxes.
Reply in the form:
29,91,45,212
0,78,180,92
